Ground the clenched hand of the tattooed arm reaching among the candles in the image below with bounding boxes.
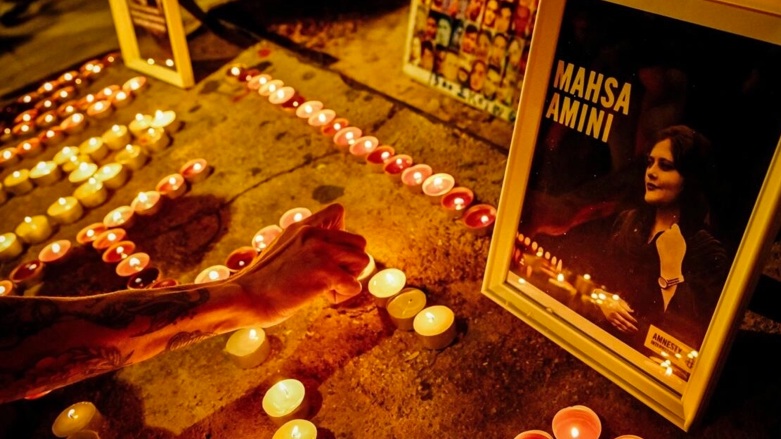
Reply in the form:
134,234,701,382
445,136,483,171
236,204,369,326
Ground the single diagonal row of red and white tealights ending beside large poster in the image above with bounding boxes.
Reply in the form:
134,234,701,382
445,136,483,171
226,65,496,235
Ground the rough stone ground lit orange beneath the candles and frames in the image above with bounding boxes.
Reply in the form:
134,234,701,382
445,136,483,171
0,0,781,439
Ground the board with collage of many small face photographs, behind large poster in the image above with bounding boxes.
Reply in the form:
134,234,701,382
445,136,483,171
408,0,538,116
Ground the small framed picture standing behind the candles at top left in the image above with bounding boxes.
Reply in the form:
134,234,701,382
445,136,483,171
109,0,194,88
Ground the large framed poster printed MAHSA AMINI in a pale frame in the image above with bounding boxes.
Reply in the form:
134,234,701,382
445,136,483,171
483,0,781,430
